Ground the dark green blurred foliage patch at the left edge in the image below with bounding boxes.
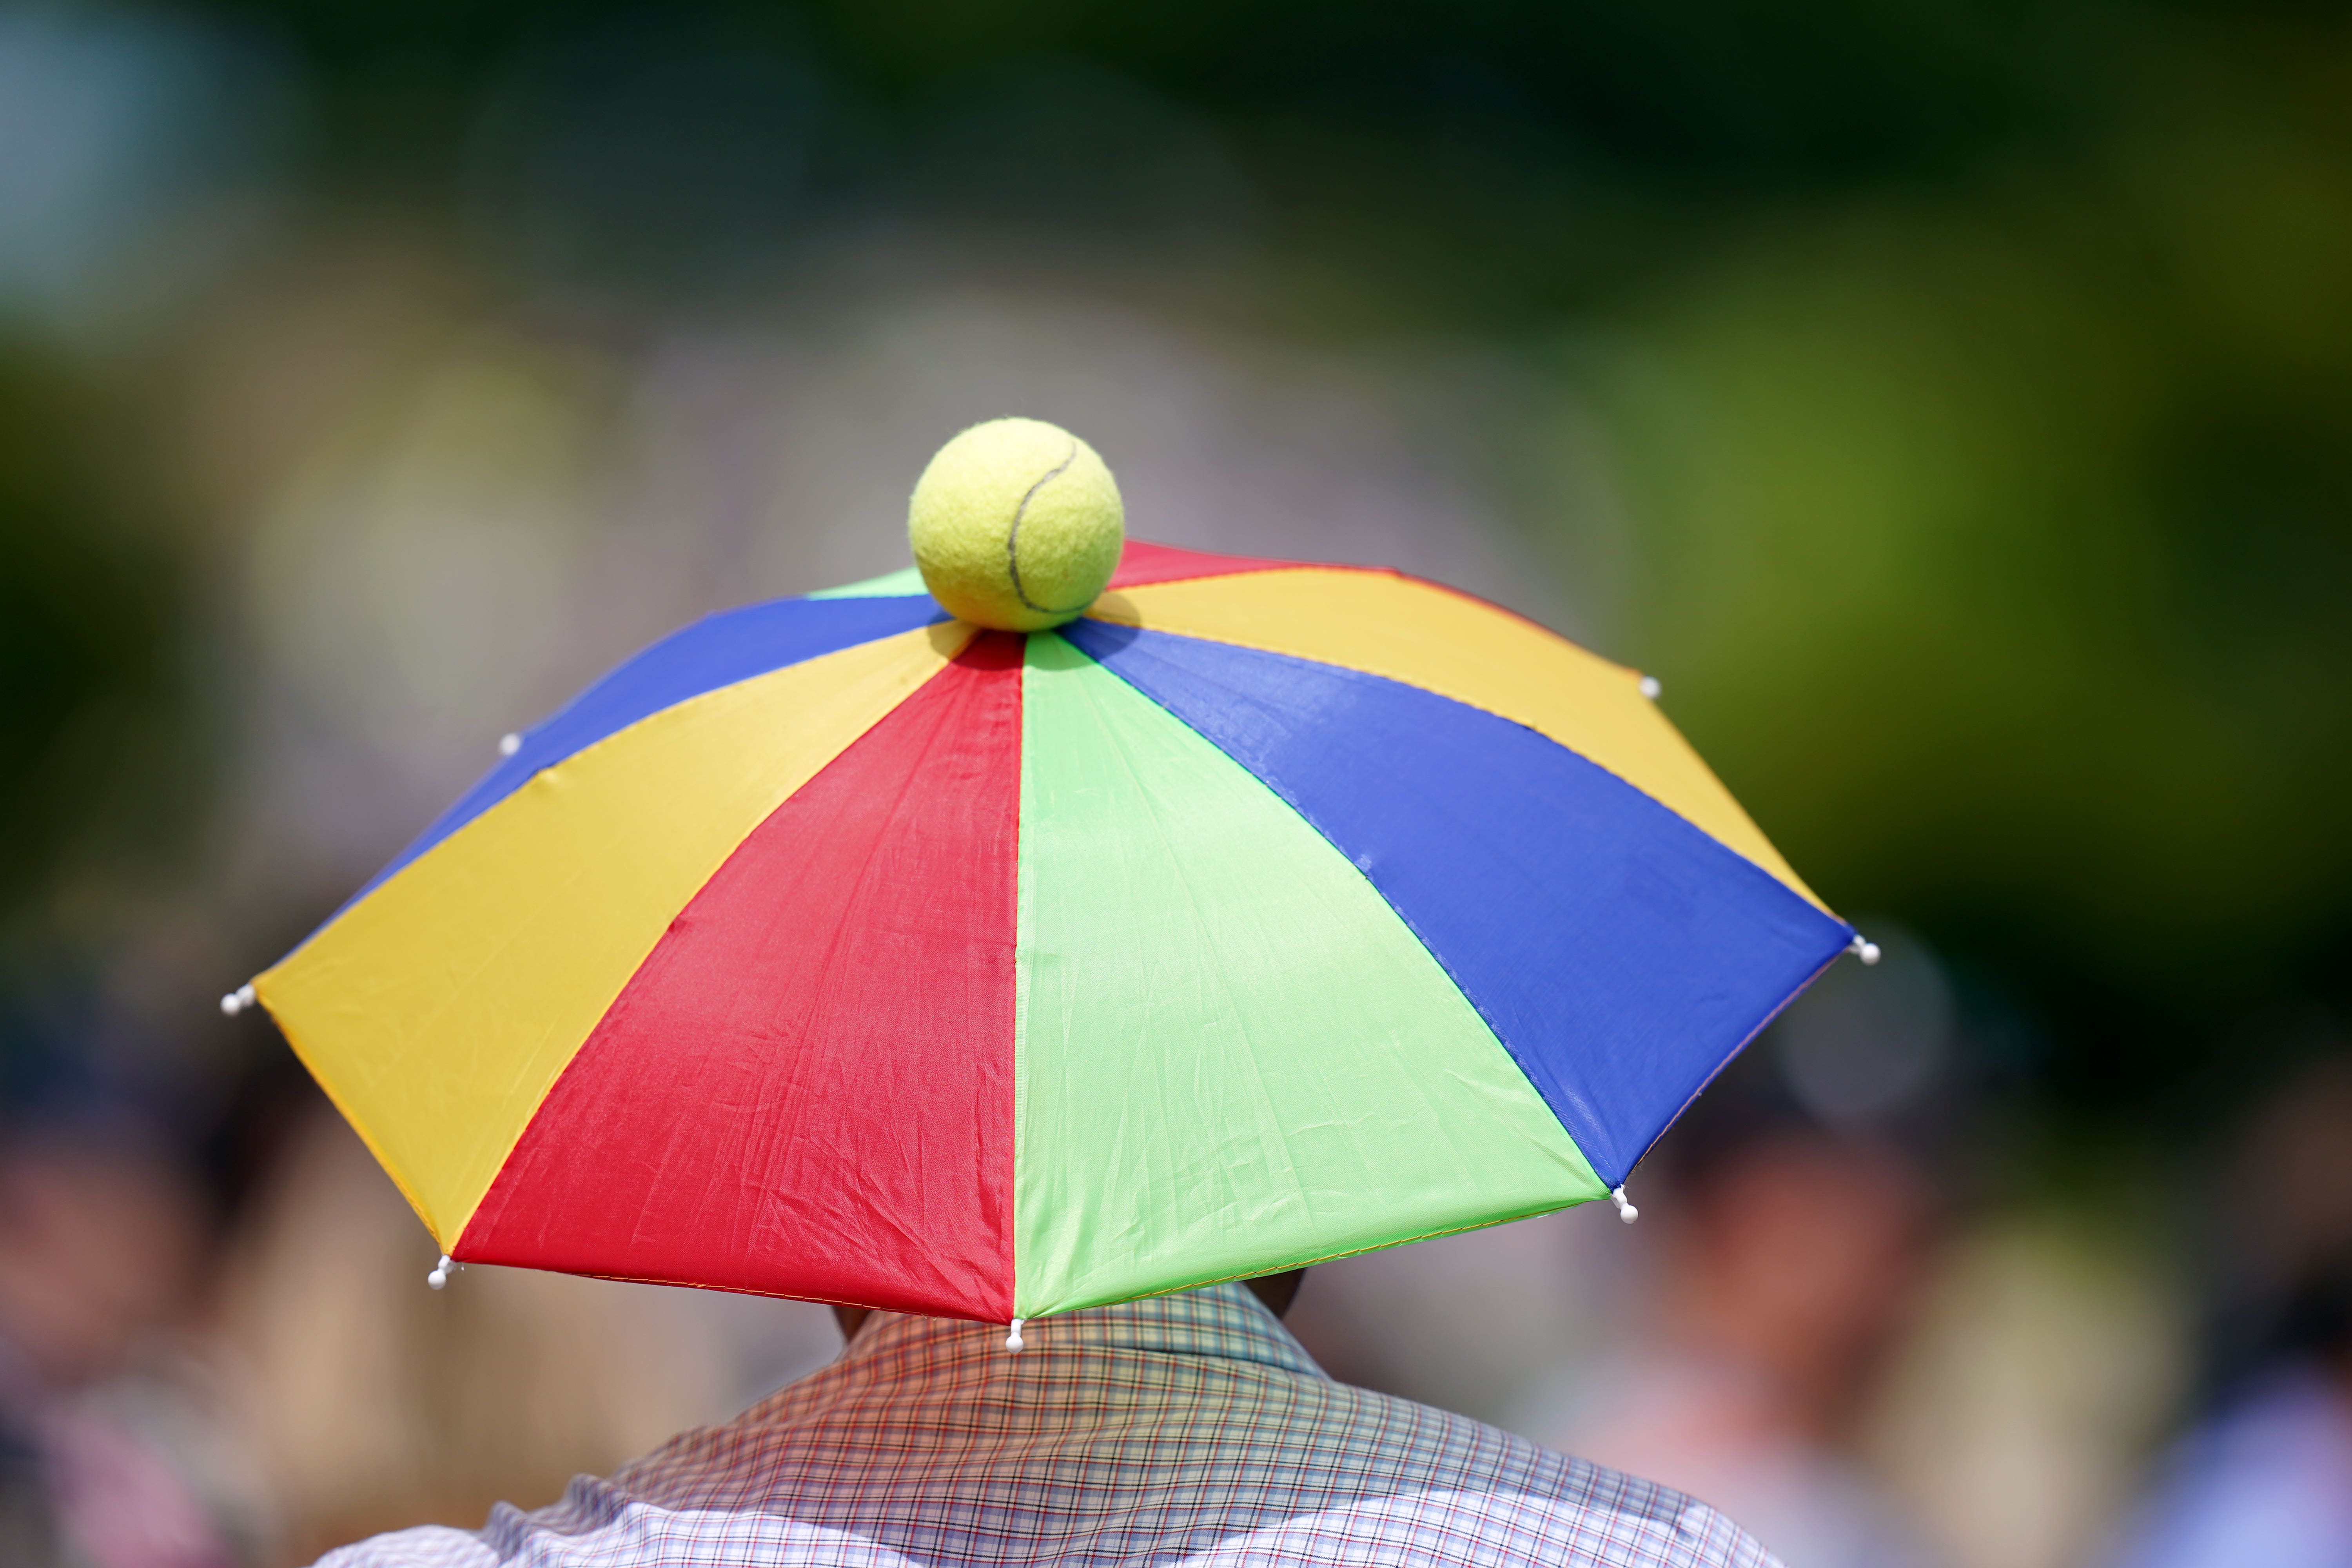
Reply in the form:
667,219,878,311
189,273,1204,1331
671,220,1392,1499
0,343,205,943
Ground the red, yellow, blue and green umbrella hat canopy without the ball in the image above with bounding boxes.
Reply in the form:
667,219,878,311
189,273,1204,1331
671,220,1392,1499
228,425,1858,1323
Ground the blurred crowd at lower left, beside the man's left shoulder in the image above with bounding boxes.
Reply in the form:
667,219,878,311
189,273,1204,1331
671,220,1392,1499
0,1062,837,1568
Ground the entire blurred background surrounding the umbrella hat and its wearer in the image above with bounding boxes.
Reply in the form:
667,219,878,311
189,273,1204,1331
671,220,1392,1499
0,0,2352,1568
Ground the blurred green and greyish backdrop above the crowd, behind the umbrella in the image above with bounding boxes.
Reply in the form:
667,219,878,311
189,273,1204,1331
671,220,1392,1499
0,0,2352,1561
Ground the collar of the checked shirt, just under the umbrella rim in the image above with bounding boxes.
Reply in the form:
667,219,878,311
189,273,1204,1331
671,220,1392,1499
842,1283,1327,1377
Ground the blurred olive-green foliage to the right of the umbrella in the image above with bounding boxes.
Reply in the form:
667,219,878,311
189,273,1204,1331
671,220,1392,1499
1595,31,2352,1112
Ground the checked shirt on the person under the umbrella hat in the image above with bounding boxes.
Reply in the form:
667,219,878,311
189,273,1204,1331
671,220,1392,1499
320,1286,1776,1568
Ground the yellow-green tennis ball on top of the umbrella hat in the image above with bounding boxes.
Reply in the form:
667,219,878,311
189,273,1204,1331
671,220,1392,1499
906,418,1127,632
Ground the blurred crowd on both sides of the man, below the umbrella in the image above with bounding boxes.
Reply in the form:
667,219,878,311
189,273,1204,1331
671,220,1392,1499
0,973,2352,1568
